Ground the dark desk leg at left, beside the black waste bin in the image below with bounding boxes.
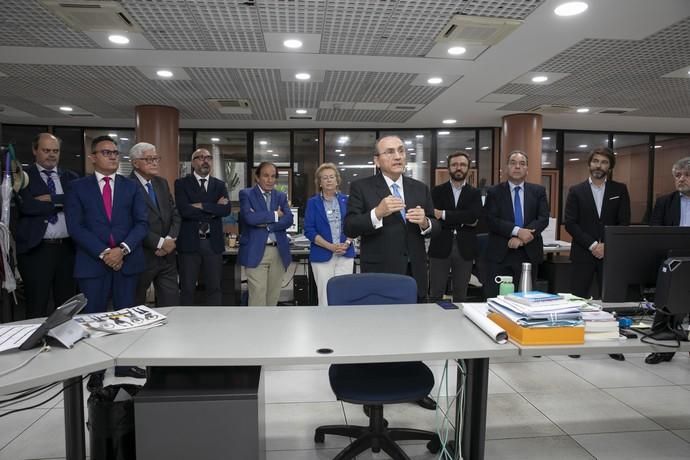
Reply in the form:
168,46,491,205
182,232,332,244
62,377,86,460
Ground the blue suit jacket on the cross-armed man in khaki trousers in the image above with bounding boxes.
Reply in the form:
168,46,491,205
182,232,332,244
237,185,293,269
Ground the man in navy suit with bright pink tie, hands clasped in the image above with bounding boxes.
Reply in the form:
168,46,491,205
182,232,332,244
65,136,148,313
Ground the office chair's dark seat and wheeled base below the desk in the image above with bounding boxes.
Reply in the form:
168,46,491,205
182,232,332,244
314,362,441,460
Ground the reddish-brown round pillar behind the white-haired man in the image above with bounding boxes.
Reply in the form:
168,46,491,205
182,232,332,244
134,105,180,192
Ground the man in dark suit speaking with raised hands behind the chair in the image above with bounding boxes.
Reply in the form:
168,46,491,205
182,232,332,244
345,136,441,409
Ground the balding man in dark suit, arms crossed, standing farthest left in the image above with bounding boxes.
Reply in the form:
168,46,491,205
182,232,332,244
15,133,78,318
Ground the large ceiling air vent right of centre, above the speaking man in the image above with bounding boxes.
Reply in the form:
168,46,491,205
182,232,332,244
436,14,522,46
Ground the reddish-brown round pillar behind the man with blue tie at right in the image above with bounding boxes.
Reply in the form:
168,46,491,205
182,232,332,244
499,113,542,184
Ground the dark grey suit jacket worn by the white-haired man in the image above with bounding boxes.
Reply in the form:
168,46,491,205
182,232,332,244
129,172,181,267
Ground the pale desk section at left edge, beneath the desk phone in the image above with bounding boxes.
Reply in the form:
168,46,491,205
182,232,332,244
0,341,114,395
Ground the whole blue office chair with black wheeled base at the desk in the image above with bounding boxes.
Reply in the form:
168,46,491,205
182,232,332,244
314,273,441,460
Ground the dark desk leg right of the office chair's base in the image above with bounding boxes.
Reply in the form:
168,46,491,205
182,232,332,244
456,358,489,460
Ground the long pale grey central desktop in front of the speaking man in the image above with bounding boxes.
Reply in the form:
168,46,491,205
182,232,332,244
111,304,517,366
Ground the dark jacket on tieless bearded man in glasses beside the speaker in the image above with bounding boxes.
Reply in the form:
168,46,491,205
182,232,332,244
429,181,482,260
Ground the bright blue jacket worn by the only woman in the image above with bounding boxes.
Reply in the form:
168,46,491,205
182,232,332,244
304,193,355,262
